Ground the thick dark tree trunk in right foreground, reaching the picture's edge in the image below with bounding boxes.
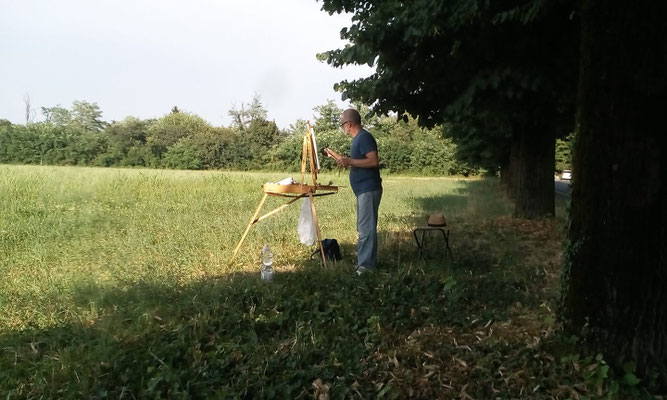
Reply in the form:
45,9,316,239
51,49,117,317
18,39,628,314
561,0,667,387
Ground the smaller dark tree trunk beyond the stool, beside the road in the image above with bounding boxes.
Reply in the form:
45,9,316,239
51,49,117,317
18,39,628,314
514,124,556,219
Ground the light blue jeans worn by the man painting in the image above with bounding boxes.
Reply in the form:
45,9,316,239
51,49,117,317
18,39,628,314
357,188,382,270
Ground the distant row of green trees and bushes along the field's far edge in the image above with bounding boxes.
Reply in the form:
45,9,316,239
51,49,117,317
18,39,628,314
0,97,482,176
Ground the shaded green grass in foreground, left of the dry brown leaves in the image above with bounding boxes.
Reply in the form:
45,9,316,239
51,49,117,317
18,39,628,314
0,260,470,398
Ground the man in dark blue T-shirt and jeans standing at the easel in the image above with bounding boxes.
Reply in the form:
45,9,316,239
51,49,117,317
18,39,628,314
336,108,382,275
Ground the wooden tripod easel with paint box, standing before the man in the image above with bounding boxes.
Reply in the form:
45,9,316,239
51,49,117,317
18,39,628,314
229,122,338,267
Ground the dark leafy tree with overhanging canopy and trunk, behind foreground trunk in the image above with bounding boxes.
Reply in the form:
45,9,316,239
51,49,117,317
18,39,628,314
319,0,578,218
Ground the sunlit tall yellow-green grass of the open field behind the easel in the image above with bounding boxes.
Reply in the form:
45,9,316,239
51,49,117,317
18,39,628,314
0,166,506,329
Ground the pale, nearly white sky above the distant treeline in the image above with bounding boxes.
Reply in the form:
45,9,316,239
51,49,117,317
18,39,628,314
0,0,372,129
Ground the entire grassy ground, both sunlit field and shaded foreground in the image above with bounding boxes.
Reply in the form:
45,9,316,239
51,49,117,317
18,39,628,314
0,166,648,399
